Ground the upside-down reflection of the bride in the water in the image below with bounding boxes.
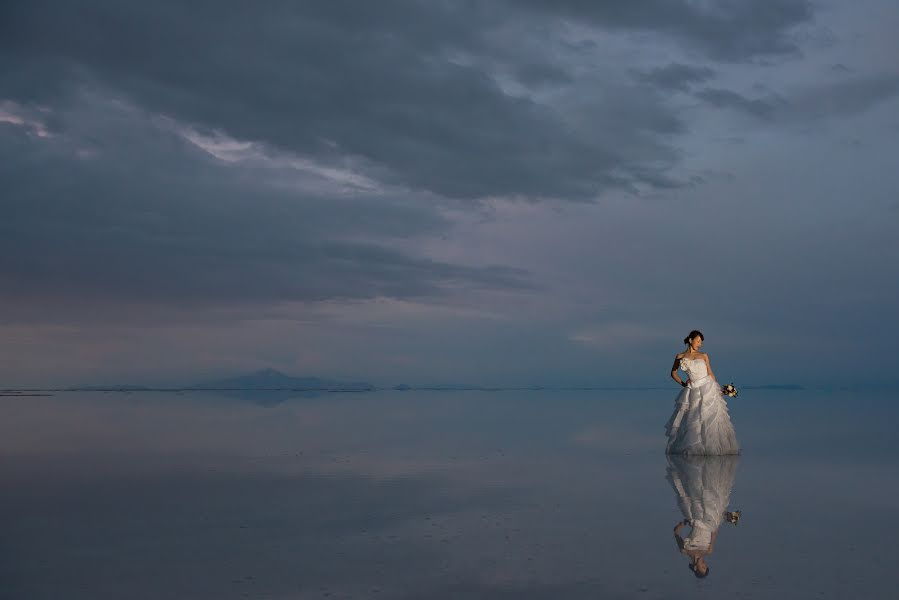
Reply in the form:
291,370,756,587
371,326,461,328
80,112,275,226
667,455,739,577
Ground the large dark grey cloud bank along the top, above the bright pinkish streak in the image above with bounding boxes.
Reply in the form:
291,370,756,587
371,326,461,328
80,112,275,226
0,0,704,199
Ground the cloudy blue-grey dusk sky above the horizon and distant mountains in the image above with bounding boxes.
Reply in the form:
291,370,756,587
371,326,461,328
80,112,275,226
0,0,899,389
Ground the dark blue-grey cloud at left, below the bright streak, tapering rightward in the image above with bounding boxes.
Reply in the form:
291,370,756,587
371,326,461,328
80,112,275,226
0,98,529,312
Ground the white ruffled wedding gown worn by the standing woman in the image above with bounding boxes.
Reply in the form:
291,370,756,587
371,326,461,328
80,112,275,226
665,358,740,455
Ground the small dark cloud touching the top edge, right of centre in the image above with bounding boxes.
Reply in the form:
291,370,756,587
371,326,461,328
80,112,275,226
516,0,813,61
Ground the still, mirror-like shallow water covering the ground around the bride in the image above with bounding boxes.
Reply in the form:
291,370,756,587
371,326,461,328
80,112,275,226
0,388,899,599
